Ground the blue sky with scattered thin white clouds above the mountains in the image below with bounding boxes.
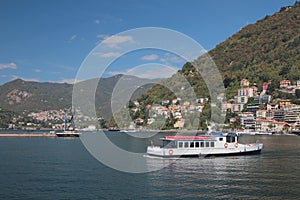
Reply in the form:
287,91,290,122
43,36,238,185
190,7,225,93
0,0,295,85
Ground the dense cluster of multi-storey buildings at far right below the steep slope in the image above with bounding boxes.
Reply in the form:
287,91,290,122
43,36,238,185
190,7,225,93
222,79,300,133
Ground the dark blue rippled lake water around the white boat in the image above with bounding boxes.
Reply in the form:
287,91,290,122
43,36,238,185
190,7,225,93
0,134,300,199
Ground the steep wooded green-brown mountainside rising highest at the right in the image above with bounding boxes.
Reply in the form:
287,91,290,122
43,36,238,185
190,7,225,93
138,2,300,103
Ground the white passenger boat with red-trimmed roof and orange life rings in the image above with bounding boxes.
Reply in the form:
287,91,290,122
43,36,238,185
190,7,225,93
147,132,263,157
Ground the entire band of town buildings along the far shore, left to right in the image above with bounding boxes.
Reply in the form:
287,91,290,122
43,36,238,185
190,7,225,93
1,78,300,133
